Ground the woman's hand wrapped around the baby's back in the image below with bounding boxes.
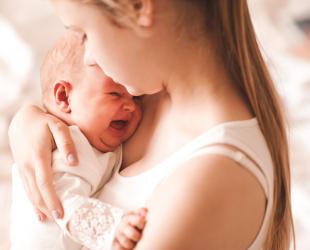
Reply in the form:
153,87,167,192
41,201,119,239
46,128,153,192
9,106,78,221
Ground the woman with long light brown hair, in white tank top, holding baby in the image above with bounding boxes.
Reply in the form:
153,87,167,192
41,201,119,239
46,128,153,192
9,0,293,250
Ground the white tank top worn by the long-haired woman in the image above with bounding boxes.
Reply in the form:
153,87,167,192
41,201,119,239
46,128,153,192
98,118,273,250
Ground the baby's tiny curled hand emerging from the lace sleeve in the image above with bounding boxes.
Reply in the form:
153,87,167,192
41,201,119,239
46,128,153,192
113,208,147,250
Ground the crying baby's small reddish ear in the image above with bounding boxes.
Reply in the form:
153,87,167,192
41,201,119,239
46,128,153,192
53,81,72,113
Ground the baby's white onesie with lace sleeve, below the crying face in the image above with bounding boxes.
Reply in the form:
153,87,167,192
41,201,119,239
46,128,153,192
52,127,123,249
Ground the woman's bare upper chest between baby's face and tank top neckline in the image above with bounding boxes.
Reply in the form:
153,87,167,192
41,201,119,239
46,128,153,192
121,94,200,176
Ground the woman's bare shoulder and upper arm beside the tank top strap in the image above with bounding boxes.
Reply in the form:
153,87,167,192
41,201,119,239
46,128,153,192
136,155,266,250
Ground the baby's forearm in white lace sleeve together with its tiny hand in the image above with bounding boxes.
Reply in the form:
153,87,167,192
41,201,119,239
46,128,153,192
67,199,146,250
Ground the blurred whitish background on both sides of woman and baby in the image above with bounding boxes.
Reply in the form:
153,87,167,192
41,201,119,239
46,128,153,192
0,0,310,250
